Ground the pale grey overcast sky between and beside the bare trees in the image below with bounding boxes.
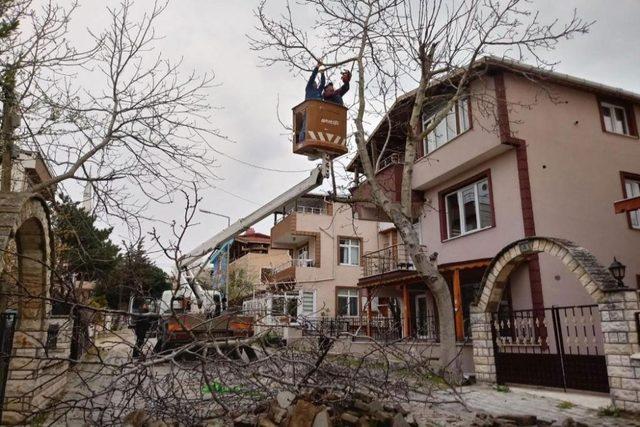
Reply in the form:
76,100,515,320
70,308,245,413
61,0,640,266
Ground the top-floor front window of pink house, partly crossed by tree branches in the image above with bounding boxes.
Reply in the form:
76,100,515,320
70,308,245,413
422,96,471,154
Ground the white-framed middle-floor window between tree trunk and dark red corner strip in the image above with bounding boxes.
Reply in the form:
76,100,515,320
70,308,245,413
444,178,493,239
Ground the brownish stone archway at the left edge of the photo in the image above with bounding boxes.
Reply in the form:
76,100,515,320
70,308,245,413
0,193,53,424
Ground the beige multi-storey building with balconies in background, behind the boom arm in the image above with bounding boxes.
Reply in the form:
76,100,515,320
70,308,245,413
271,194,381,319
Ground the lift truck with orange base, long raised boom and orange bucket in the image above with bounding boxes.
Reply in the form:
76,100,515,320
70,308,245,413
156,100,348,351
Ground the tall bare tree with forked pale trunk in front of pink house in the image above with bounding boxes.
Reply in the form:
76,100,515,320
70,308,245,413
251,0,590,367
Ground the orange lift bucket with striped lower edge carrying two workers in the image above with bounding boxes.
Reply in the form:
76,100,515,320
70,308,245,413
293,99,348,160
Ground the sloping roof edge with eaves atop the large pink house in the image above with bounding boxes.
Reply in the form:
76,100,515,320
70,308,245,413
347,55,640,172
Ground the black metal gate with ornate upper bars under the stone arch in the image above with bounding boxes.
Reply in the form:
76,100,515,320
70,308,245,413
491,305,609,392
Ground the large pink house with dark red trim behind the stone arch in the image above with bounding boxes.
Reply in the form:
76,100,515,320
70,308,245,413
350,58,640,382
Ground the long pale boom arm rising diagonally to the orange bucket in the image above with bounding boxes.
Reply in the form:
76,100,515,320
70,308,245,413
180,162,329,307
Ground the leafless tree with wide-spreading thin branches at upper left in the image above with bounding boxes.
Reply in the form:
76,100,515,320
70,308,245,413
0,0,220,234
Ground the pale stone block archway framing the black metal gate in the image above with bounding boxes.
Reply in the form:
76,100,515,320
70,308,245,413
471,236,640,411
